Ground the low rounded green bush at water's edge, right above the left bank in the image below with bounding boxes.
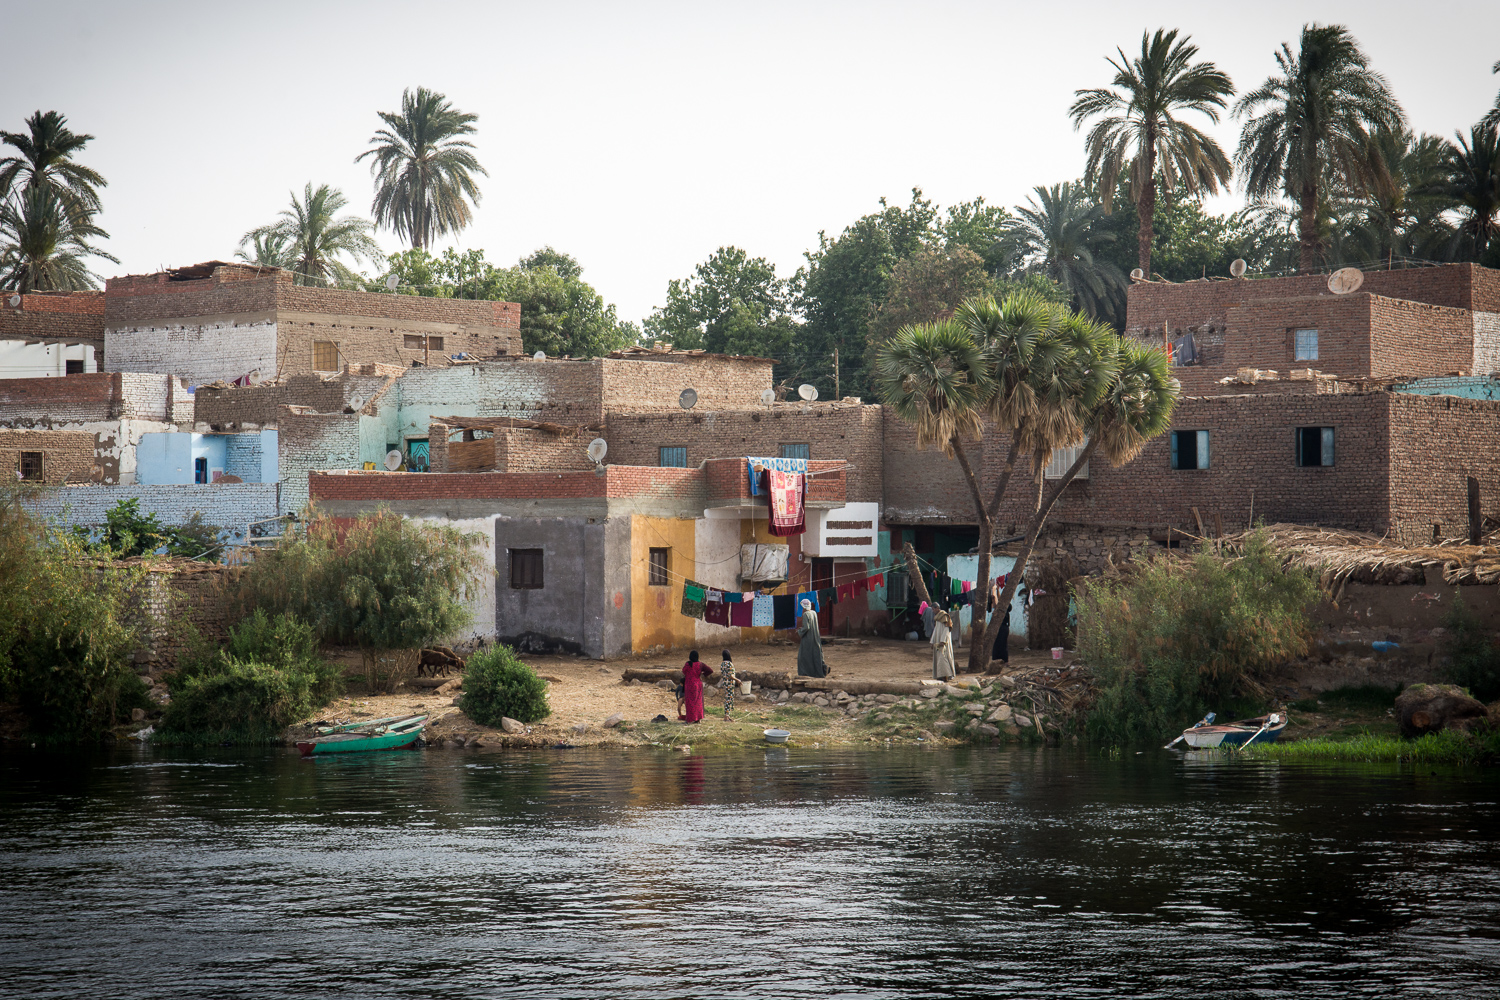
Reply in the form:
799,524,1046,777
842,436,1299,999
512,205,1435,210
156,609,344,744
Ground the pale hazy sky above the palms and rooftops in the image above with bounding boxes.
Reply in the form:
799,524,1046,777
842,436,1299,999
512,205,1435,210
0,0,1500,321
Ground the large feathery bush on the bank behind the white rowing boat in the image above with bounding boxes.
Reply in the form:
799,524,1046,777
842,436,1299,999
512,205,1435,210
1077,534,1319,742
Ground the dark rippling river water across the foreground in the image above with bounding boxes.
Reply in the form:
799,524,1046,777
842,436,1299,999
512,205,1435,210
0,747,1500,1000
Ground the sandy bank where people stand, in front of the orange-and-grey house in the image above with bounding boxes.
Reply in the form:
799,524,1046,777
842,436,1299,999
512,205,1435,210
298,637,1053,747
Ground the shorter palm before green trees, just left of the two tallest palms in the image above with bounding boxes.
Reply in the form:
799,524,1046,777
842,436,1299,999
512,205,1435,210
1011,181,1125,318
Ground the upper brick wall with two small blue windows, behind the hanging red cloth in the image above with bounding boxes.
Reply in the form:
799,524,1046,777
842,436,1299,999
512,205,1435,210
605,403,885,502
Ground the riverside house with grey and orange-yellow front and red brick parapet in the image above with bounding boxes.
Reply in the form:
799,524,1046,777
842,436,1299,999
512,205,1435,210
311,456,885,657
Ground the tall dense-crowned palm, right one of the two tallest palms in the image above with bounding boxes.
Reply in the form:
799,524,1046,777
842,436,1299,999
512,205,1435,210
1235,24,1406,274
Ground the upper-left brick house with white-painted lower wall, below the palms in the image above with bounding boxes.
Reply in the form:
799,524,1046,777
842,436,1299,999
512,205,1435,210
104,261,521,385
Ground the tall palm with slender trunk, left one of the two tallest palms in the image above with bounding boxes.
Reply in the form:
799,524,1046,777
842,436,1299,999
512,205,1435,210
1068,28,1235,274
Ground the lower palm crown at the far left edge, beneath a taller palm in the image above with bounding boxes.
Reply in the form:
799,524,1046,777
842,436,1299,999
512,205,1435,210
0,184,120,292
